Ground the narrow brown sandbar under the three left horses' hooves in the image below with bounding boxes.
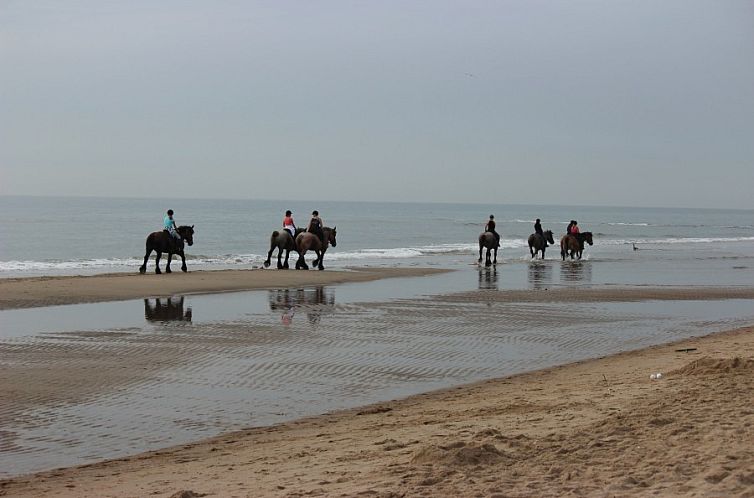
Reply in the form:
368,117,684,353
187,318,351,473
0,268,446,310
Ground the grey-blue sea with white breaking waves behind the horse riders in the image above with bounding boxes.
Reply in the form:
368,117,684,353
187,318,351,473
0,196,754,288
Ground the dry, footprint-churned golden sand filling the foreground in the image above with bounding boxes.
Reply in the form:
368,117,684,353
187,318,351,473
0,327,754,496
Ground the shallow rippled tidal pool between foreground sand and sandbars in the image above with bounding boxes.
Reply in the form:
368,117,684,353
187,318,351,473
0,278,754,476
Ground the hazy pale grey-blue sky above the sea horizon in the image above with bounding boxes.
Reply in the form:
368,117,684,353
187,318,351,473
0,0,754,209
